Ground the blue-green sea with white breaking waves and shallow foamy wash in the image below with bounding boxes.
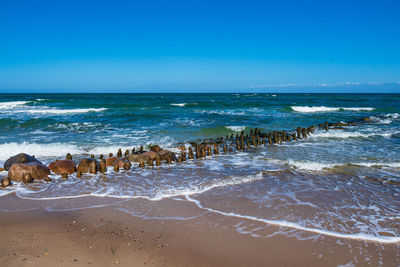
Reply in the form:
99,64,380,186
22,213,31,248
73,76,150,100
0,93,400,249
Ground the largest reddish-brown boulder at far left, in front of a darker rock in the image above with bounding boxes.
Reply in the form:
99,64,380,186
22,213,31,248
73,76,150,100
8,161,50,182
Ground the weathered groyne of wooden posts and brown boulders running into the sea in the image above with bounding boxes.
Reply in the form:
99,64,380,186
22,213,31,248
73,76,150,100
1,120,366,187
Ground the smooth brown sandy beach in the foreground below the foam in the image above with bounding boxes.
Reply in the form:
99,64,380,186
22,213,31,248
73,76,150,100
0,195,400,266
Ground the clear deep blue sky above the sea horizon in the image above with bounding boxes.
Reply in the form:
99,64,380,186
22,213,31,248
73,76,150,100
0,0,400,92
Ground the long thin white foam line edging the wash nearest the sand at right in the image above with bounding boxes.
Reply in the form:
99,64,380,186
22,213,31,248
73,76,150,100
186,195,400,244
